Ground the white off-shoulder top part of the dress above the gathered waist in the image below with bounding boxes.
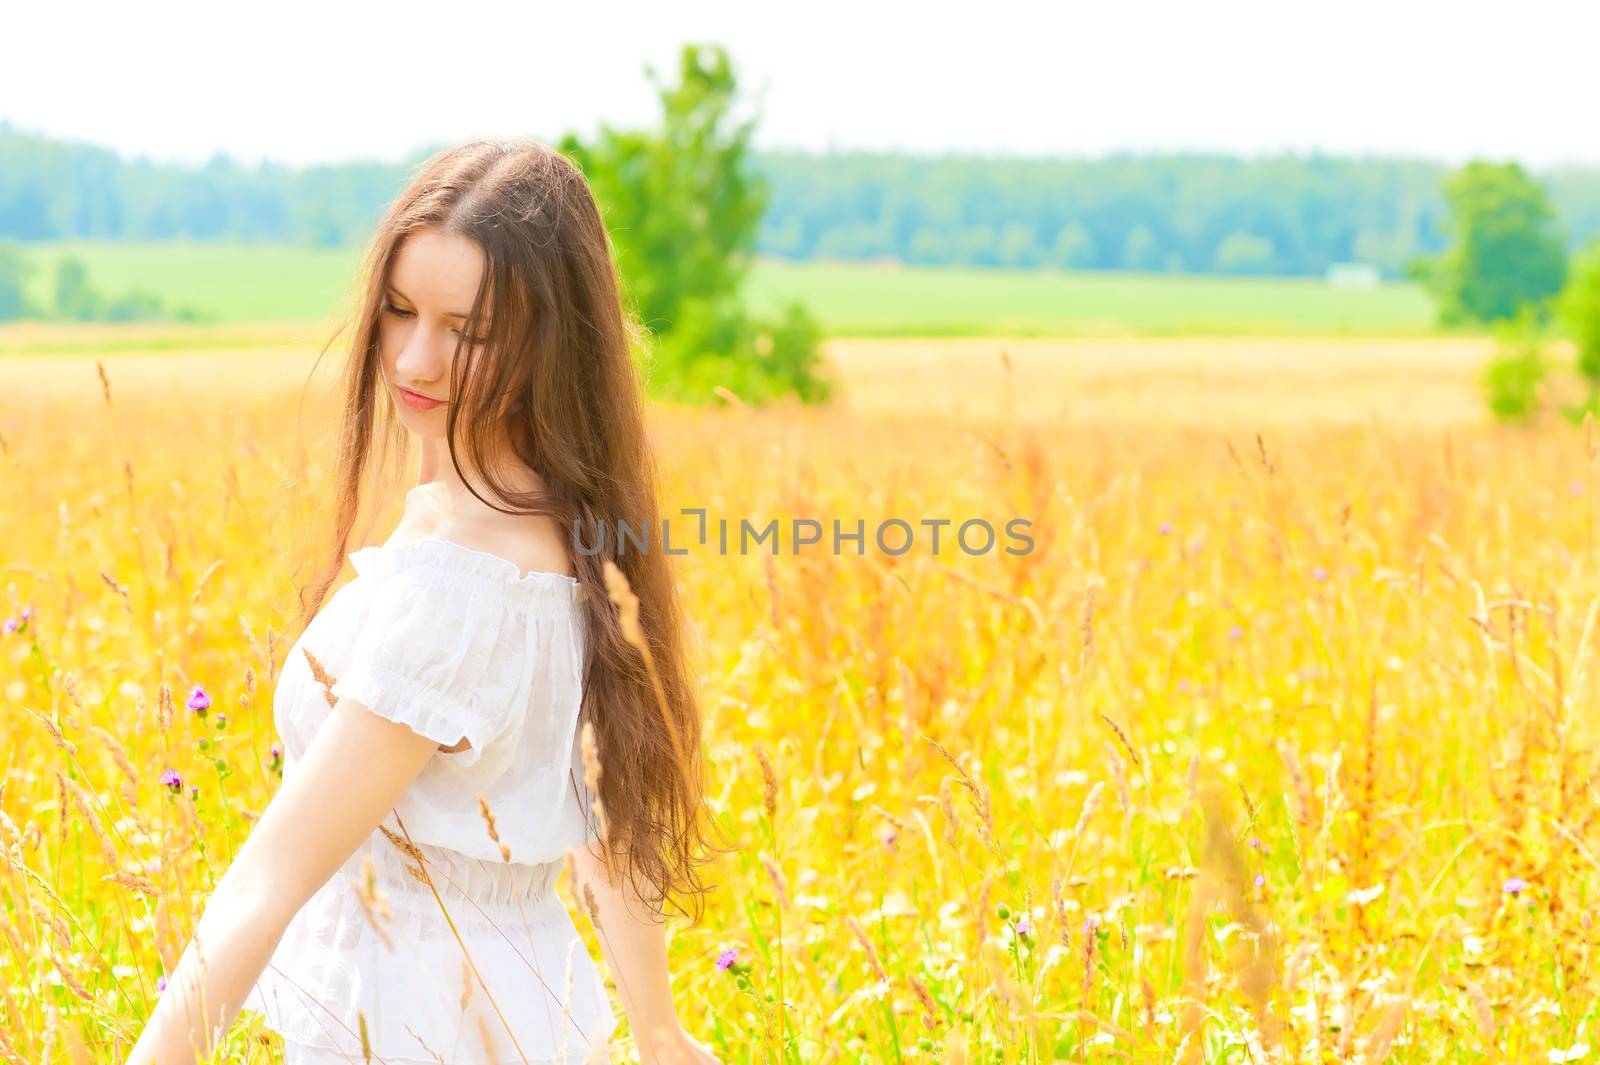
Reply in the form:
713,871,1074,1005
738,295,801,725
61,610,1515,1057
315,539,592,865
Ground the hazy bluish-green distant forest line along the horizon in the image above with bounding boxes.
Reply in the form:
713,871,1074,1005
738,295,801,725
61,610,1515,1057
0,123,1600,277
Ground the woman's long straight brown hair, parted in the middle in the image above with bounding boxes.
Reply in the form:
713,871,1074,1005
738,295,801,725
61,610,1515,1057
298,141,726,921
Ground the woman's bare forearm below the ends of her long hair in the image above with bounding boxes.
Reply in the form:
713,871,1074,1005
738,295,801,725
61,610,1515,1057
573,841,717,1065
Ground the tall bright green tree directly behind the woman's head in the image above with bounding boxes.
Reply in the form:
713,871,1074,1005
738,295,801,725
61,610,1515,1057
558,45,830,401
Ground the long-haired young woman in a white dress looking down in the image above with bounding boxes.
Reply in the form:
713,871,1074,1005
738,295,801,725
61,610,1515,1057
128,142,720,1065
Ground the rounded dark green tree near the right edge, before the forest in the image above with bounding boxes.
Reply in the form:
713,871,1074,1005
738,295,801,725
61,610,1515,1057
1427,162,1566,325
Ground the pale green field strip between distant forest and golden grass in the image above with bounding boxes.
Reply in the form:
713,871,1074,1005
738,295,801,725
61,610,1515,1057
15,241,1434,336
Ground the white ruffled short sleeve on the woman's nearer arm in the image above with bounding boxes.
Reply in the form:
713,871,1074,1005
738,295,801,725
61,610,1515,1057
330,546,531,768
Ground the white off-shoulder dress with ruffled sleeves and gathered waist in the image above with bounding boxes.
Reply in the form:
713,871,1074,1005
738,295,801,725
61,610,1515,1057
245,502,618,1065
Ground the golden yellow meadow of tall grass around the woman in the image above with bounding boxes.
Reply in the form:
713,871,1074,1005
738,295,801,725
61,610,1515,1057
0,329,1600,1065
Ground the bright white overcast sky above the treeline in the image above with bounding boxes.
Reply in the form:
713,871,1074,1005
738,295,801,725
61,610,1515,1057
0,0,1600,166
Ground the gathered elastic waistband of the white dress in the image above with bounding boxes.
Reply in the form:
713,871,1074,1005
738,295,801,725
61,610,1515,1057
348,838,565,910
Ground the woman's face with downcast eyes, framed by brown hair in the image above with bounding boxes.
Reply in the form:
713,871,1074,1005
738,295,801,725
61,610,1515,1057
378,225,483,440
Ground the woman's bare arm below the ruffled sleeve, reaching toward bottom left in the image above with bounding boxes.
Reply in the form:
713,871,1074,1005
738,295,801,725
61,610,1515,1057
126,699,438,1065
